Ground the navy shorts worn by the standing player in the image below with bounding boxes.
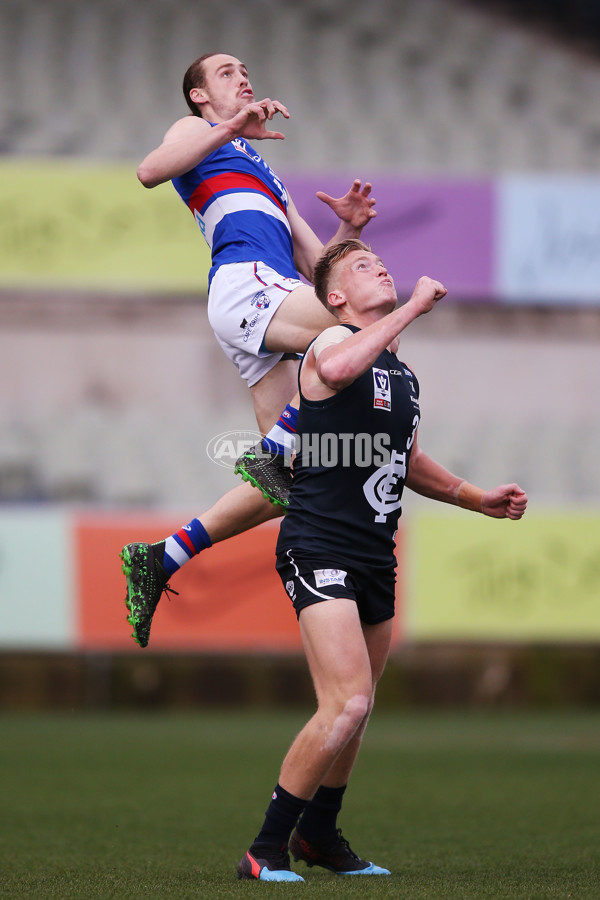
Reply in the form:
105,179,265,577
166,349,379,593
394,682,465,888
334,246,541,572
276,550,396,625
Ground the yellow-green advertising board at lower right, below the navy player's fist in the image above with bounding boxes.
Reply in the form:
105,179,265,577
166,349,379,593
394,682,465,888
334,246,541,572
406,509,600,642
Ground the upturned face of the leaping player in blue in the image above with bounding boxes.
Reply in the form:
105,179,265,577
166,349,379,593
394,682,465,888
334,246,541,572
190,53,254,120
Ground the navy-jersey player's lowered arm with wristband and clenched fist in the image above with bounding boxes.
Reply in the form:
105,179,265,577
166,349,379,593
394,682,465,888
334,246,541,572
406,438,527,520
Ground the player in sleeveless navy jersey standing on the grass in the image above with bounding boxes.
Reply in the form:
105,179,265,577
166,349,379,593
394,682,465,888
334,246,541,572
238,240,527,881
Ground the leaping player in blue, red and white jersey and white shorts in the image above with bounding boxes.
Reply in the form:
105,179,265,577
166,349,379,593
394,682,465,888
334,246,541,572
121,53,376,647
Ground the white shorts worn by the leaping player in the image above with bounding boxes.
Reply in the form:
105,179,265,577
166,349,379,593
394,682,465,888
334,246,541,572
208,262,302,387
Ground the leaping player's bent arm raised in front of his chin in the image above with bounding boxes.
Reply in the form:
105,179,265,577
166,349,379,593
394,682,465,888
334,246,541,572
137,98,289,188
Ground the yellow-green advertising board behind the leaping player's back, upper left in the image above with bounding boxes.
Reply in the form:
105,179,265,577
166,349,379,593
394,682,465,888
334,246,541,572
0,159,210,293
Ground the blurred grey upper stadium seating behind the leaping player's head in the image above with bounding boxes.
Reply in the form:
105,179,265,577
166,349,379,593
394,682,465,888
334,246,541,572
0,0,600,173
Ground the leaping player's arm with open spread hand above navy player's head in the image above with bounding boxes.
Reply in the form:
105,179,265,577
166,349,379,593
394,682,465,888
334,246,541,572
288,178,377,281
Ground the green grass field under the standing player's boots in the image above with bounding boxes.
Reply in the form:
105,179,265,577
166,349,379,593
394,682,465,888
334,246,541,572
0,712,600,900
